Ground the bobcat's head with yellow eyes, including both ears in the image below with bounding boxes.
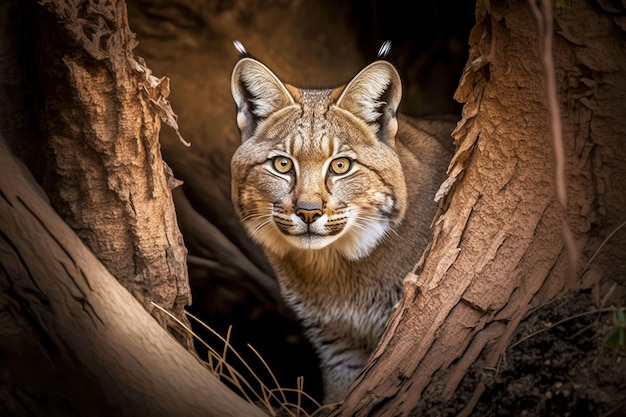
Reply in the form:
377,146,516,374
231,57,407,260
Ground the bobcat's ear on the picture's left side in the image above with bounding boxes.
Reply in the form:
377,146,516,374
230,57,294,140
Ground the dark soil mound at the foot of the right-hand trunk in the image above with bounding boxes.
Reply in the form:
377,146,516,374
419,291,626,417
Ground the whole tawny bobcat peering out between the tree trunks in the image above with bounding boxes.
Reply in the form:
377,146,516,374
231,47,454,403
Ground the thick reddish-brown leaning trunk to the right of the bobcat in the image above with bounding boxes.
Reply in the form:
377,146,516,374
333,0,626,416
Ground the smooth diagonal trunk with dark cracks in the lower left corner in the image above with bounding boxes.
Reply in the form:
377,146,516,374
0,136,264,417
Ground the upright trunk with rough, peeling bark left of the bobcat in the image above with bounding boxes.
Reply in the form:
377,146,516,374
3,0,191,346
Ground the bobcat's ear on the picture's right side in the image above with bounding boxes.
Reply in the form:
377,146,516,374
337,61,402,145
